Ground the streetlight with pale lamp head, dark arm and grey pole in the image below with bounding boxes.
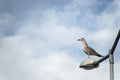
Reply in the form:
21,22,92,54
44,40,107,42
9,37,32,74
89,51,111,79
79,29,120,80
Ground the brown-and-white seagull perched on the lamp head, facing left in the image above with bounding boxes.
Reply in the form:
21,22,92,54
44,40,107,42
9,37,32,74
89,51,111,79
78,38,103,57
